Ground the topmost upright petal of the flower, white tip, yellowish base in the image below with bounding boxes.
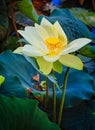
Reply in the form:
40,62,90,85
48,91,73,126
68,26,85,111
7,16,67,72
41,18,58,37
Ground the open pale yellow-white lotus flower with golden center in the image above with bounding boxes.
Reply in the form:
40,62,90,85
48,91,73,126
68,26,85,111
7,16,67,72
15,18,91,73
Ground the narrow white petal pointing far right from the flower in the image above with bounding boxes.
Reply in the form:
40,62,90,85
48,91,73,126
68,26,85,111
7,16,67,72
62,38,91,54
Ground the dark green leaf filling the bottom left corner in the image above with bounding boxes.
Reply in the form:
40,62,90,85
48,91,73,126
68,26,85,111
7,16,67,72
0,95,60,130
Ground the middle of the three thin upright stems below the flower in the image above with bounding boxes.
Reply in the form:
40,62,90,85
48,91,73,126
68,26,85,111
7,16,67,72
52,83,56,122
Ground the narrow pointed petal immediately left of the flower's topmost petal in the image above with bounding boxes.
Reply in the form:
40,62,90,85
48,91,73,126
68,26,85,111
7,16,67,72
35,23,49,41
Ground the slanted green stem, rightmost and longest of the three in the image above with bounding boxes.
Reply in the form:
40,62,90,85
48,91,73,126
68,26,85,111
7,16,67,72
58,67,70,126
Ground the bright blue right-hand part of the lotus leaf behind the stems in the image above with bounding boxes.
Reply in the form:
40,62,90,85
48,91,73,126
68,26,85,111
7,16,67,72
54,69,94,107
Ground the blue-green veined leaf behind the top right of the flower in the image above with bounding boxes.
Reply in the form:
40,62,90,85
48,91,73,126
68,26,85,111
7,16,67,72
39,9,90,41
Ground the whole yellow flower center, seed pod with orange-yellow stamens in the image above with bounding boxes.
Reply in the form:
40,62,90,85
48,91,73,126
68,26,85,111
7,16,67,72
45,37,66,57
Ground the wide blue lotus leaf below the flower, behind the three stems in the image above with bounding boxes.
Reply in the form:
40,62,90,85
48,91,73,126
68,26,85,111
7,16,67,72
0,51,94,107
